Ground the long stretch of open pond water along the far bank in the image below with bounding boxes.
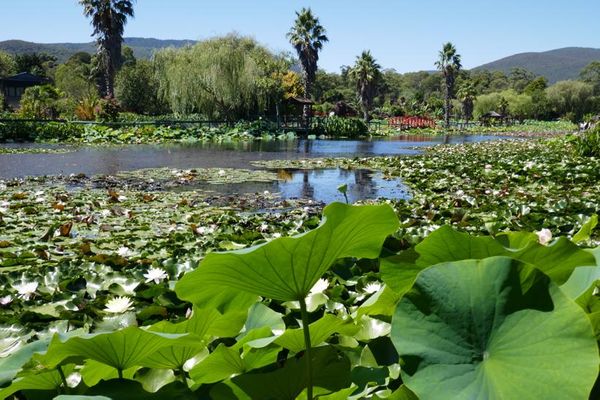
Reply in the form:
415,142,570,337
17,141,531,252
0,135,501,179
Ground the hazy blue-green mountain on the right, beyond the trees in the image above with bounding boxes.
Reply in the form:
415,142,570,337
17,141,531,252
473,47,600,83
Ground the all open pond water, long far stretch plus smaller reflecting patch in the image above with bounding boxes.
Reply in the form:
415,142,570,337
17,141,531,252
0,135,502,203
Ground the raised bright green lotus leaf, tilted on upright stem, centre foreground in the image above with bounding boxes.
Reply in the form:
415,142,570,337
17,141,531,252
176,203,398,303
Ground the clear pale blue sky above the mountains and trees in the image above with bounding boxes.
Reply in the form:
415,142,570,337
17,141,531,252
0,0,600,72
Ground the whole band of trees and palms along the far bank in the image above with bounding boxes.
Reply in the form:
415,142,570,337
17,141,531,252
0,0,600,125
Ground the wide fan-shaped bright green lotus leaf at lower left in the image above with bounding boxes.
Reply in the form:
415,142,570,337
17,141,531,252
42,326,198,371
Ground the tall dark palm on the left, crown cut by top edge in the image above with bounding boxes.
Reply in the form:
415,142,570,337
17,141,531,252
79,0,135,98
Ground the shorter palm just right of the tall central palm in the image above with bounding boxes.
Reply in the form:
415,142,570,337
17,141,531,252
350,50,381,121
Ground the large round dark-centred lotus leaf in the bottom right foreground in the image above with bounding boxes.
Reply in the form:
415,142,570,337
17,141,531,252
391,257,600,400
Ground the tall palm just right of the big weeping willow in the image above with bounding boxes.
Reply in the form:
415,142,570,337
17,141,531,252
287,8,329,117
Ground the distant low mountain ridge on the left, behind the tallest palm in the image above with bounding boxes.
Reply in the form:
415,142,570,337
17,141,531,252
0,37,195,63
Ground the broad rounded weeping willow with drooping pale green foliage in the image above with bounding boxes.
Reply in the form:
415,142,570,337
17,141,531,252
154,34,286,120
